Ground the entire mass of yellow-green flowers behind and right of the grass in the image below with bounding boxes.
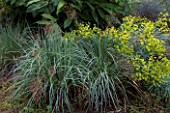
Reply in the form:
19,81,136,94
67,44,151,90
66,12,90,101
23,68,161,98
65,14,170,84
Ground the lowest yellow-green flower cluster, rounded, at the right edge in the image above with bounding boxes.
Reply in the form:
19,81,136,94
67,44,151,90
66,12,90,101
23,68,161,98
133,56,170,84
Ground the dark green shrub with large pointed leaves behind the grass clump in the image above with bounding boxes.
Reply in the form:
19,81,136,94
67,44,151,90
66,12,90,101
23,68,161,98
3,0,128,28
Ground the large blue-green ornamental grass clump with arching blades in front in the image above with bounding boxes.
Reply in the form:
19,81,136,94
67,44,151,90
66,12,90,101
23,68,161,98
13,25,131,112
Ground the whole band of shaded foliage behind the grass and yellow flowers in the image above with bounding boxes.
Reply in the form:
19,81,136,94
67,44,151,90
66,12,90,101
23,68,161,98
0,0,170,30
